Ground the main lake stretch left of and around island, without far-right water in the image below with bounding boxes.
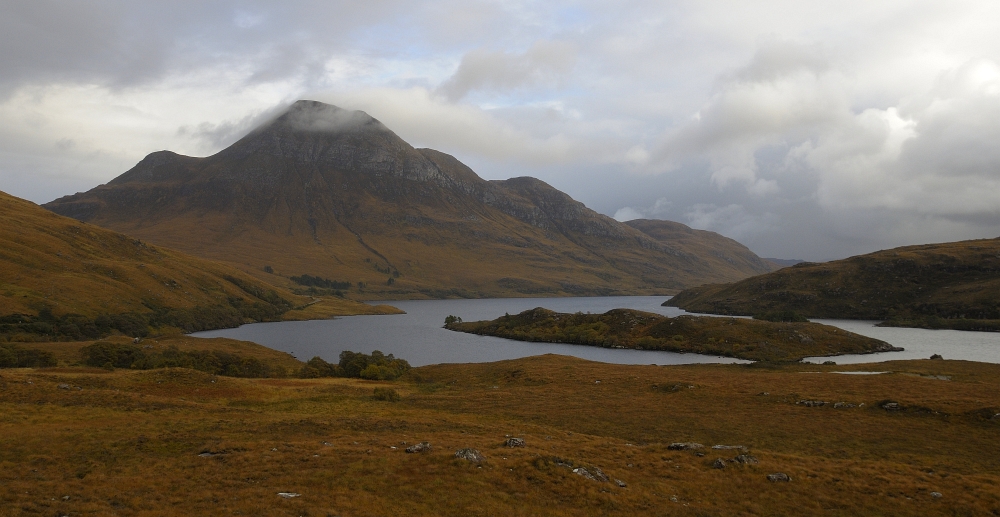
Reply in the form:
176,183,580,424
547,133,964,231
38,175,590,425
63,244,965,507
192,296,747,366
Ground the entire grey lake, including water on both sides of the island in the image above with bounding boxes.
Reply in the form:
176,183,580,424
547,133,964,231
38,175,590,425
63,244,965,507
193,296,1000,366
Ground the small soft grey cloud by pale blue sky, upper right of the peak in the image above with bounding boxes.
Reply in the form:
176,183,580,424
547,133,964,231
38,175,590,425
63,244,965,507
438,41,576,101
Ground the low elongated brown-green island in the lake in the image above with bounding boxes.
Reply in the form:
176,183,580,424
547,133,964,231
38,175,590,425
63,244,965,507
445,307,896,362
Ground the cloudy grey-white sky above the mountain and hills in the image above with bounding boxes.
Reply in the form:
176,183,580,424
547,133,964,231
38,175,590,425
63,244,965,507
0,0,1000,260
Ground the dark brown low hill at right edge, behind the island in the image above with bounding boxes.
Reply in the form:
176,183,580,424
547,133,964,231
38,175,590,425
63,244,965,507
664,239,1000,331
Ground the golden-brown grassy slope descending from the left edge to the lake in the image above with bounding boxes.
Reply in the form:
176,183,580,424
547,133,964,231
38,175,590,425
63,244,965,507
0,188,390,341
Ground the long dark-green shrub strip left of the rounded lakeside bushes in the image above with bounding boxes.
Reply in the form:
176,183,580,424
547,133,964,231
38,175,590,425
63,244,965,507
81,342,274,378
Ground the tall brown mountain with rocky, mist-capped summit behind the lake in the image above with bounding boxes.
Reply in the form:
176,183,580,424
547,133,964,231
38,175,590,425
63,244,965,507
45,101,772,299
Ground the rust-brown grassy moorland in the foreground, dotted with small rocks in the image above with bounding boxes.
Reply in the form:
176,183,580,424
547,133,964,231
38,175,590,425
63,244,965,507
0,356,1000,517
